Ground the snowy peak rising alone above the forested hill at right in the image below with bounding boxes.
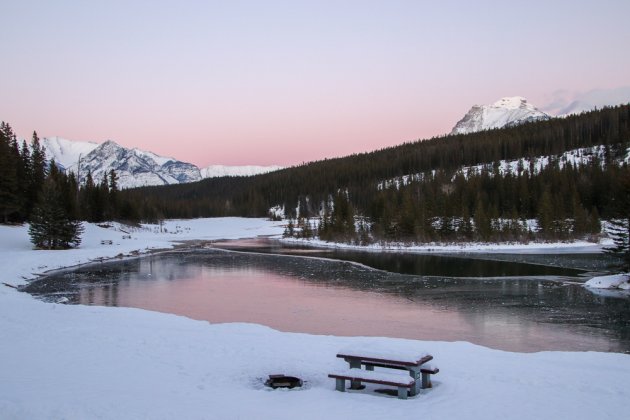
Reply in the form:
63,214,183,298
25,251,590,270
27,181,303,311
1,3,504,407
451,96,551,134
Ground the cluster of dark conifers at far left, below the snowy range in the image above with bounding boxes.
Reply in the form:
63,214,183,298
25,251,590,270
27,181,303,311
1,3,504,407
0,122,130,249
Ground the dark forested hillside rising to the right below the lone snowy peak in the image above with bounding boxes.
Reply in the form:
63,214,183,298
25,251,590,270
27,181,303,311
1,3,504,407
122,106,630,240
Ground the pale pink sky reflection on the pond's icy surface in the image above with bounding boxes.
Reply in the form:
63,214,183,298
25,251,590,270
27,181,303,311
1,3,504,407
79,266,610,352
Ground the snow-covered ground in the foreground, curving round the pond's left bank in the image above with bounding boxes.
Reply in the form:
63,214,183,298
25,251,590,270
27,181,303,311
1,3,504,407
0,218,630,420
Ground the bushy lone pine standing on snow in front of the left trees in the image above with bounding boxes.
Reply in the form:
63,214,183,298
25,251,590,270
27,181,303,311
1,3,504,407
28,177,83,249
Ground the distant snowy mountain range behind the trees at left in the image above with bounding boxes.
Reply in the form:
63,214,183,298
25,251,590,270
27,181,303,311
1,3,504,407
41,137,282,188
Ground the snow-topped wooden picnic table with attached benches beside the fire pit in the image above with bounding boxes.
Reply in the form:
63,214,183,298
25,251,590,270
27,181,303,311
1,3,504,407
328,349,440,398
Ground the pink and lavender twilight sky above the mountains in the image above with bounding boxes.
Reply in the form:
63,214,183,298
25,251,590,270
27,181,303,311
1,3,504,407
0,0,630,166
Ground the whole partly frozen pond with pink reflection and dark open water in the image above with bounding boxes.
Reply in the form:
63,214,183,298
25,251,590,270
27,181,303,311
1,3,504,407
26,243,630,352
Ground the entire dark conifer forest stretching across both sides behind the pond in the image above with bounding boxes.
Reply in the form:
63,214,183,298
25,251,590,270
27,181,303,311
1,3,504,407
0,105,630,256
